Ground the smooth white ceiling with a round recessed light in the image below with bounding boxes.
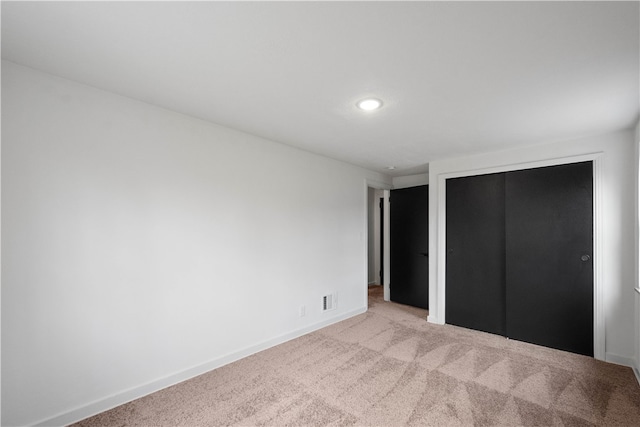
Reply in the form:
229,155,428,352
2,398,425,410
2,2,640,176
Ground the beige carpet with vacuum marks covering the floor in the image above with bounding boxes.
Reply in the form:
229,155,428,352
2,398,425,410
76,287,640,426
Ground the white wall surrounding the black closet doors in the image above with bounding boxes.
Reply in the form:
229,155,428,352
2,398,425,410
429,130,637,365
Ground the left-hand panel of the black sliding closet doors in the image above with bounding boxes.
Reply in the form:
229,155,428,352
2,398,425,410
445,173,506,335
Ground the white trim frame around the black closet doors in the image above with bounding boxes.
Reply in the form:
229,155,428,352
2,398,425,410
427,152,605,360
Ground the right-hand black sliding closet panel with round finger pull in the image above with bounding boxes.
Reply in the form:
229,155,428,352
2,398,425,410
505,162,593,356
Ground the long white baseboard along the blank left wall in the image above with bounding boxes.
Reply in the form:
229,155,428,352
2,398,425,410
34,307,367,427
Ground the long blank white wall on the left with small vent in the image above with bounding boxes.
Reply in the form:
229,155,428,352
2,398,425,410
2,62,391,425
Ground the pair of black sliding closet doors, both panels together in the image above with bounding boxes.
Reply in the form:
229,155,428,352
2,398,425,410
445,162,593,356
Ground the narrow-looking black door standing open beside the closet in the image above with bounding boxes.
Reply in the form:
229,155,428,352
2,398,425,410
389,185,429,308
